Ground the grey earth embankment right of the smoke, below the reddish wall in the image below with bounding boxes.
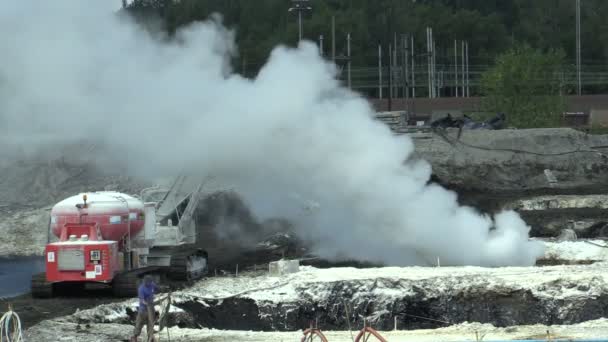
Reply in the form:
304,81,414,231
412,128,608,238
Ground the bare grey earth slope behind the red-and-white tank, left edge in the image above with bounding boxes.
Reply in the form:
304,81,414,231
0,156,144,256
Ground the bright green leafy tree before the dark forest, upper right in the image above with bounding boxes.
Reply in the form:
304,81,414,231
481,45,566,128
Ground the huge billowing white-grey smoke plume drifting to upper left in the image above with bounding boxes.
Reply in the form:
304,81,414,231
0,0,542,266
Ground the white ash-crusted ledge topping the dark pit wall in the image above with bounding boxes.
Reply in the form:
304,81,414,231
174,263,608,306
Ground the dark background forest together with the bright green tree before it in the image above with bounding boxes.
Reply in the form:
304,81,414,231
128,0,608,127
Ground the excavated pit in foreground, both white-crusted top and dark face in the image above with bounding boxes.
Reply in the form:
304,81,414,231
58,256,608,331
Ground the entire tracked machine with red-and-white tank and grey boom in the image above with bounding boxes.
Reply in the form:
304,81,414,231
32,176,216,298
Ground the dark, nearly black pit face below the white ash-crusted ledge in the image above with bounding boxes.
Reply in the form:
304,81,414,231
165,280,608,331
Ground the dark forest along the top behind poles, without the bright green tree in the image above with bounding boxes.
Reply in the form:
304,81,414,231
129,0,608,68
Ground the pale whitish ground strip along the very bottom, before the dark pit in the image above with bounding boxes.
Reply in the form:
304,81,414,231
26,319,608,342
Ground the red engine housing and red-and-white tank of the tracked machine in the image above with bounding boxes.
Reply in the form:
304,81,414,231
45,192,145,283
